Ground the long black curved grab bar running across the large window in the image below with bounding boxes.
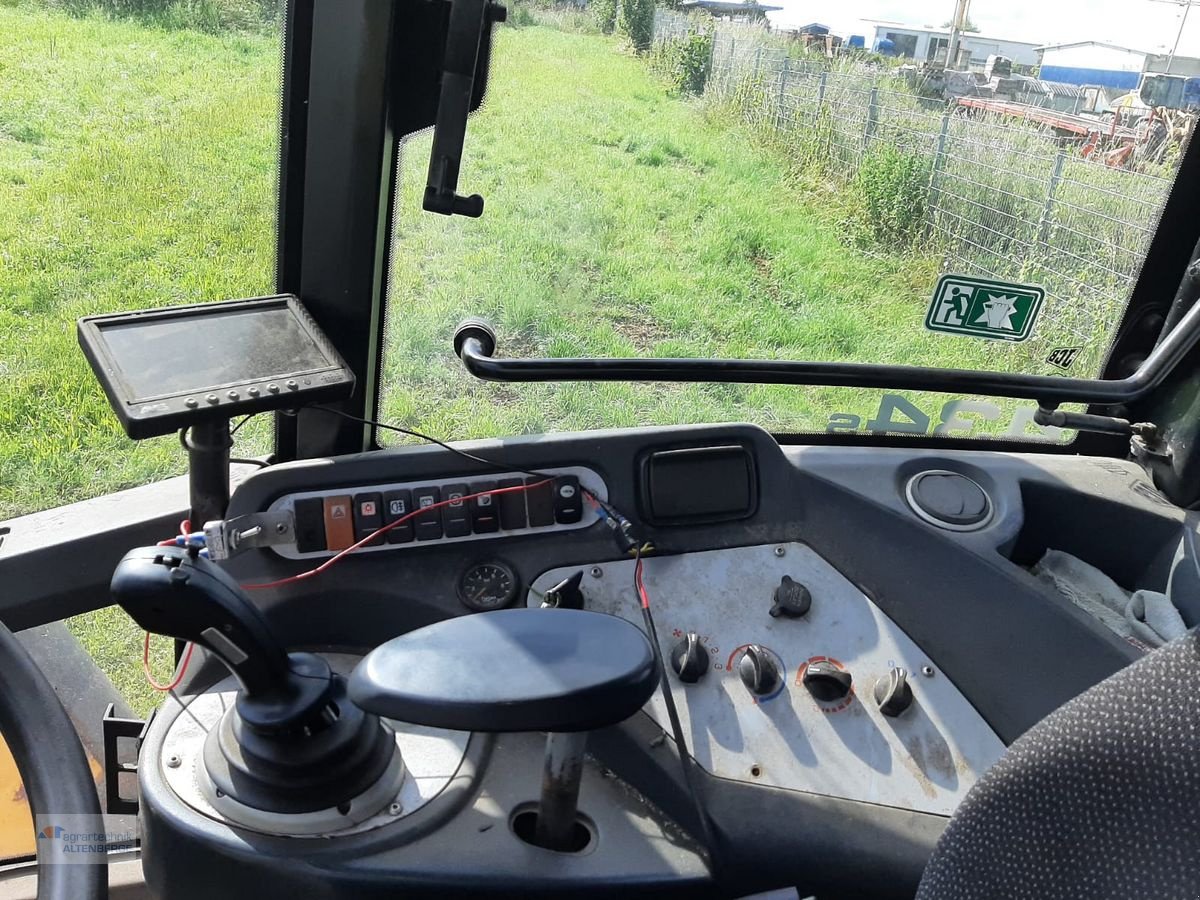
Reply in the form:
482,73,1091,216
454,305,1200,409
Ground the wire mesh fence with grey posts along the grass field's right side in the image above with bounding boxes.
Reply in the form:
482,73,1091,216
656,12,1172,370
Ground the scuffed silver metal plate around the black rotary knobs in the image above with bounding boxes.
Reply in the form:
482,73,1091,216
529,544,1004,815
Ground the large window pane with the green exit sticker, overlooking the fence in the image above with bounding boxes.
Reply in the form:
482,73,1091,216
383,0,1200,442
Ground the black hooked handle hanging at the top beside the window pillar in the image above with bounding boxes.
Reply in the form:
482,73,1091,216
424,0,508,218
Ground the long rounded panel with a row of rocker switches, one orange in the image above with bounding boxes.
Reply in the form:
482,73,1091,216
262,467,608,559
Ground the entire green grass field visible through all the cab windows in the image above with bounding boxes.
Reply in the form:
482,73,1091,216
0,5,1065,709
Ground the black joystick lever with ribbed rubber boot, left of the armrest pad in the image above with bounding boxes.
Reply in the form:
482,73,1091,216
112,547,403,833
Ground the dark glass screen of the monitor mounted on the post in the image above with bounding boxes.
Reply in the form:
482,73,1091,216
100,306,338,402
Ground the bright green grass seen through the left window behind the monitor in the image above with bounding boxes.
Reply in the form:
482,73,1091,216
0,7,280,520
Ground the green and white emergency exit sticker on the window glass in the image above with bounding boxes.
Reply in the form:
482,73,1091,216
925,275,1046,342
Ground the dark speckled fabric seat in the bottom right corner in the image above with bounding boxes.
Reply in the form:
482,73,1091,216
917,631,1200,900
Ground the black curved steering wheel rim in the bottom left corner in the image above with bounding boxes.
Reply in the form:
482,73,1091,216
0,622,108,900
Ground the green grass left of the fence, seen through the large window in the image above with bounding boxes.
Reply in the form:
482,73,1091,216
384,28,1060,448
